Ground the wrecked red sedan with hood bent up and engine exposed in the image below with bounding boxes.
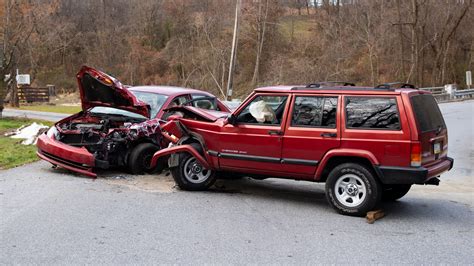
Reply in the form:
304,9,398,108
37,66,230,177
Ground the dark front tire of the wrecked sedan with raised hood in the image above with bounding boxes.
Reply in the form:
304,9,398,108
128,143,160,175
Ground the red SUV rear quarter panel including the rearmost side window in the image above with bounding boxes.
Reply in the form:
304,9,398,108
341,94,411,167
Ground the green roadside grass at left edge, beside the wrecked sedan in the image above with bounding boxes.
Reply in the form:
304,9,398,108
0,118,52,169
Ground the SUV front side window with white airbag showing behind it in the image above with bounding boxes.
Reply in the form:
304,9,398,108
237,95,288,125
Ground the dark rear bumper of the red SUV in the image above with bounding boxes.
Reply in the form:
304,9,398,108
375,157,454,184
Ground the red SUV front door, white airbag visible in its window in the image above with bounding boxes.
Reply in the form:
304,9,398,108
219,94,289,173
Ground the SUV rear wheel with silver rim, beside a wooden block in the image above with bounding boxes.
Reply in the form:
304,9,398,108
326,163,382,216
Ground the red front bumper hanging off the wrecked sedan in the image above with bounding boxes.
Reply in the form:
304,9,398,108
36,134,97,177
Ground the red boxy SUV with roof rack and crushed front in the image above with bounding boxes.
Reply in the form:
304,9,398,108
152,83,453,215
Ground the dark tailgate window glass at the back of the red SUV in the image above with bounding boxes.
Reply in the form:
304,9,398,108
410,94,446,132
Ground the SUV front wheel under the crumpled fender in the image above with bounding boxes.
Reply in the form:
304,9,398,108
171,143,216,191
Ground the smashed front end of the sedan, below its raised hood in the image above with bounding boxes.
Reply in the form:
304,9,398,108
37,114,167,177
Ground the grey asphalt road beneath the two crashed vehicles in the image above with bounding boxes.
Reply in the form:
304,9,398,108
0,101,474,265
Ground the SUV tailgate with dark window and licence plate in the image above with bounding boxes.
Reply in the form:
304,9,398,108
410,93,448,166
